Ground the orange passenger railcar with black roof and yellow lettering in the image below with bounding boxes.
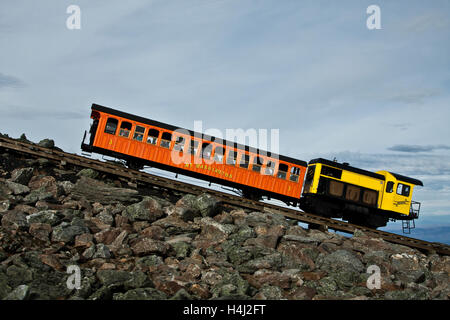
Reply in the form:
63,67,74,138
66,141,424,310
81,104,307,204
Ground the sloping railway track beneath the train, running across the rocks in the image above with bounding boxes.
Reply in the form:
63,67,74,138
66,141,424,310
0,137,450,255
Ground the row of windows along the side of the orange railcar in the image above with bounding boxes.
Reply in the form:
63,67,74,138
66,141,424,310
105,118,300,182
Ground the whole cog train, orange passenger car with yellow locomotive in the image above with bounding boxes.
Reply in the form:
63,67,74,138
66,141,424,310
81,104,423,232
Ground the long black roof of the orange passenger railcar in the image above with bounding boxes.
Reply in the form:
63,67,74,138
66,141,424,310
91,103,307,167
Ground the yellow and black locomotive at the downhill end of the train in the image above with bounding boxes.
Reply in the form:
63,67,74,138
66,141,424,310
300,158,423,232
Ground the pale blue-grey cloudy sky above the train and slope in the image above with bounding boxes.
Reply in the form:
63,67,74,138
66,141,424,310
0,0,450,243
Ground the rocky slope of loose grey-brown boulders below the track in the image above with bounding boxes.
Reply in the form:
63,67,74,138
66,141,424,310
0,136,450,300
